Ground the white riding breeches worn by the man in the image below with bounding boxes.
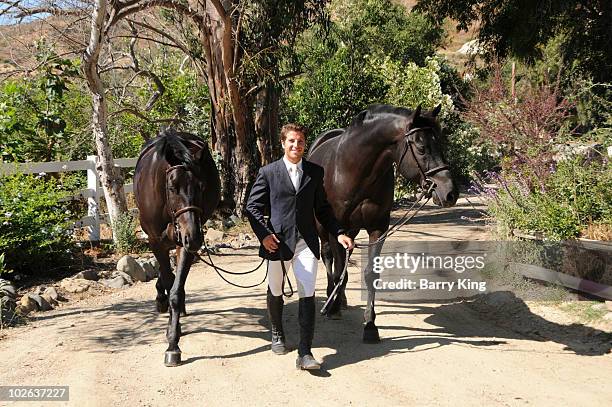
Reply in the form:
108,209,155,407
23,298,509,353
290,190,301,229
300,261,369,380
268,239,318,298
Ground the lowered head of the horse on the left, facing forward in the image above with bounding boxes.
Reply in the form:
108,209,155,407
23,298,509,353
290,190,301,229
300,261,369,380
166,137,209,252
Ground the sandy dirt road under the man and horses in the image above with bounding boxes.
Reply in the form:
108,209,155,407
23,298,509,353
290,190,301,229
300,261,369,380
0,201,612,406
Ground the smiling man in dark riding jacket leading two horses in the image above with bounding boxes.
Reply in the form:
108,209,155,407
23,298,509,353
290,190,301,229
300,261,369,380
246,123,353,370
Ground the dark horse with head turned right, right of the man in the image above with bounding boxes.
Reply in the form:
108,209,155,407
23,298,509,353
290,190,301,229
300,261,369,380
308,105,459,342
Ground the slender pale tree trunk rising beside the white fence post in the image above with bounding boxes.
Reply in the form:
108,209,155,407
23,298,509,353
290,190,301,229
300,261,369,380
83,0,127,238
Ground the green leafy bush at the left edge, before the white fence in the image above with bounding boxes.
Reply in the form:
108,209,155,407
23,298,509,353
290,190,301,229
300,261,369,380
0,175,76,274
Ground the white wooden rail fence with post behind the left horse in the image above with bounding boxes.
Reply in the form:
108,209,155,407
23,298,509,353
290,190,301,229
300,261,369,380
0,155,137,241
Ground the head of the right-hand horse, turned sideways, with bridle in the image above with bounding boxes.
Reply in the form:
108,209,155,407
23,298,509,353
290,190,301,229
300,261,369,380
394,106,459,207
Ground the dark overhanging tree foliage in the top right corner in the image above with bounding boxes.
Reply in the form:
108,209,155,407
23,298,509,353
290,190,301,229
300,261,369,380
415,0,612,82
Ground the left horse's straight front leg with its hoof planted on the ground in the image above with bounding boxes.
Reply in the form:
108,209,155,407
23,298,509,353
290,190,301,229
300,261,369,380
164,250,194,366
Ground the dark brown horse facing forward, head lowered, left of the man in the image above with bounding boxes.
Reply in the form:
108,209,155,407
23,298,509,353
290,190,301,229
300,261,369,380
134,129,220,366
